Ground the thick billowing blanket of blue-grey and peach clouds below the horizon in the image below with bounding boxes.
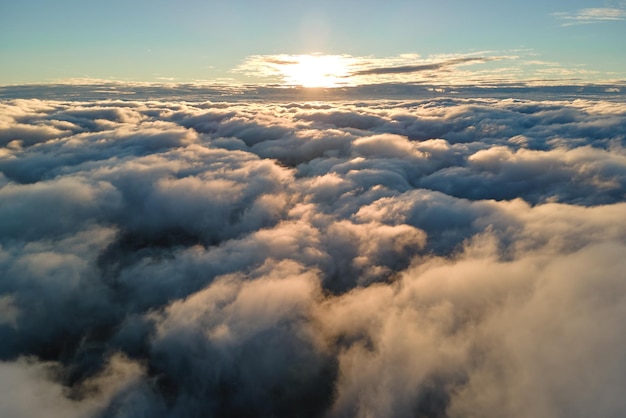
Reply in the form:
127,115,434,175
0,93,626,418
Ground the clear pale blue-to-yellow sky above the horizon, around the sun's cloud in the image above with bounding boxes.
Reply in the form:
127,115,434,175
0,0,626,84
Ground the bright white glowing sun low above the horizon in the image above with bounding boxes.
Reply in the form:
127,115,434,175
280,54,350,87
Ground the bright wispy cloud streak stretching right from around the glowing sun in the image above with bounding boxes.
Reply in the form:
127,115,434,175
232,50,616,88
